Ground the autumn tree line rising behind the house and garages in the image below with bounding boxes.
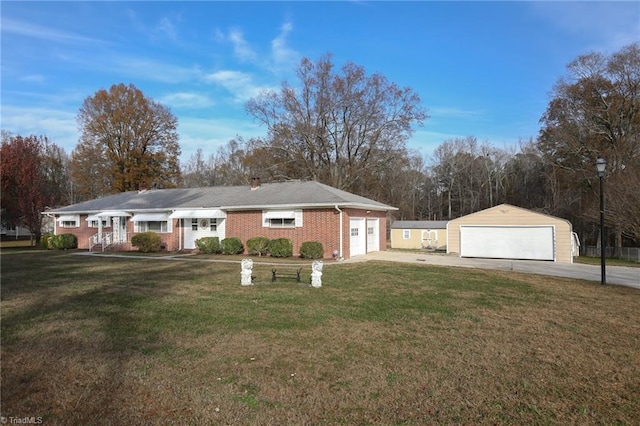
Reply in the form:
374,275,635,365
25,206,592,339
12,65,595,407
2,43,640,247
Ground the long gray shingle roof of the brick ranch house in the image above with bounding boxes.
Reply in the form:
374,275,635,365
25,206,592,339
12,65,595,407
47,181,397,213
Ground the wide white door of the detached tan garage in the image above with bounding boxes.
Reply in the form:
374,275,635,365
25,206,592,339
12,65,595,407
460,225,555,260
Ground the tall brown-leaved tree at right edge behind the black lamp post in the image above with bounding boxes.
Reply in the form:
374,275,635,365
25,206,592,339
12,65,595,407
539,43,640,247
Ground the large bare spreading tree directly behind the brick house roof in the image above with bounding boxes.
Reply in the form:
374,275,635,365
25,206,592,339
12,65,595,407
247,54,427,195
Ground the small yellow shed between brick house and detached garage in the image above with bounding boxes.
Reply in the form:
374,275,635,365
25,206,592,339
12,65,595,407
391,220,447,251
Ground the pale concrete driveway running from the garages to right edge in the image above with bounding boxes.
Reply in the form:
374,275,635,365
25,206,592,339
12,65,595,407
345,251,640,289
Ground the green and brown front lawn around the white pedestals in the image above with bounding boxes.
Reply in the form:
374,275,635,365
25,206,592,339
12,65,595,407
1,250,640,425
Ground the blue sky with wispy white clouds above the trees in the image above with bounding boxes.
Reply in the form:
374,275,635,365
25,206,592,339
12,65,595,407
0,1,640,162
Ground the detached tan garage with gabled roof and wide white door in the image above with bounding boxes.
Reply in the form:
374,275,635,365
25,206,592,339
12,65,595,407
447,204,573,263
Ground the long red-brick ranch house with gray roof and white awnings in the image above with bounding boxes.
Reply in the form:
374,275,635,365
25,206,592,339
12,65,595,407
45,178,397,259
